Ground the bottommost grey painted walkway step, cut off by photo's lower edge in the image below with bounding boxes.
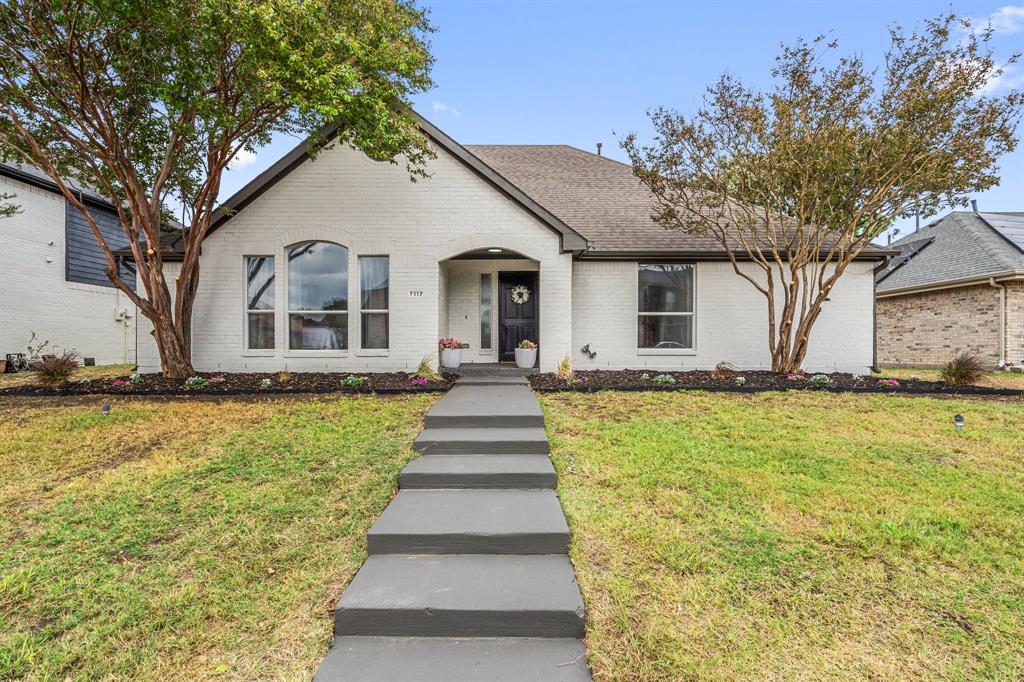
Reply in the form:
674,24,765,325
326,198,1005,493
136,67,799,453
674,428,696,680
313,637,591,682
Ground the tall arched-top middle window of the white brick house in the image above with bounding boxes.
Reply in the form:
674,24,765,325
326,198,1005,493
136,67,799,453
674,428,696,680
288,242,348,350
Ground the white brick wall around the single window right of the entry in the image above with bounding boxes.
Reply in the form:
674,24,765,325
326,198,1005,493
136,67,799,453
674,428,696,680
572,261,874,373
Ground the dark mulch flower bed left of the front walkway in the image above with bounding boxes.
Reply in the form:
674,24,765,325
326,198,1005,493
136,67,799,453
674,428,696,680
0,372,457,396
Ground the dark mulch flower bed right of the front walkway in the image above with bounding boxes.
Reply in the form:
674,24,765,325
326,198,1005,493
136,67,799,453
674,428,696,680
527,370,1024,397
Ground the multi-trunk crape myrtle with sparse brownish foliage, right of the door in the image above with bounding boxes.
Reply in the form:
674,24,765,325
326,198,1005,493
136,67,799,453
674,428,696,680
622,15,1022,372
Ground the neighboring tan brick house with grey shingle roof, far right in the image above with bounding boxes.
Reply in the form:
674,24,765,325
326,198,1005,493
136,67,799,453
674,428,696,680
876,211,1024,368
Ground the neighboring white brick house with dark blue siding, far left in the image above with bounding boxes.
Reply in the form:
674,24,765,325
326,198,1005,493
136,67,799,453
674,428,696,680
0,164,135,365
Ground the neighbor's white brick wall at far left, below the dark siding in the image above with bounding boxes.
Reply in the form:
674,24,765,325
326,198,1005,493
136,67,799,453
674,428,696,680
0,176,136,365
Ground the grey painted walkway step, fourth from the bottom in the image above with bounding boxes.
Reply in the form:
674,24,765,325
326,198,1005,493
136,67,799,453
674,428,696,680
399,455,555,489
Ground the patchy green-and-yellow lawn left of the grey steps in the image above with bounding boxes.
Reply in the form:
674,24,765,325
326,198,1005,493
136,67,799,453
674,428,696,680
0,396,436,680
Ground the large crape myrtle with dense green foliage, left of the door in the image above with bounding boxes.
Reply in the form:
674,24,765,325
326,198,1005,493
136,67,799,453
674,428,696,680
0,0,432,378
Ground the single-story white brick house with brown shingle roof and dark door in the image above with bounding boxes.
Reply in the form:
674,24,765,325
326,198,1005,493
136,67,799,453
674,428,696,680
138,114,878,372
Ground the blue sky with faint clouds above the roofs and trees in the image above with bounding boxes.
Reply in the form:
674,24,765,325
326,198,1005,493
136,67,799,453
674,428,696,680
222,0,1024,241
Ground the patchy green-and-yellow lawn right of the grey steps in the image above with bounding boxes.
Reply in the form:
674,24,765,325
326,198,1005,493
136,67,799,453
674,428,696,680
542,391,1024,681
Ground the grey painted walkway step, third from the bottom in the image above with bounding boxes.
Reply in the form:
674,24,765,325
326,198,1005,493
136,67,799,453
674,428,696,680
367,491,569,554
